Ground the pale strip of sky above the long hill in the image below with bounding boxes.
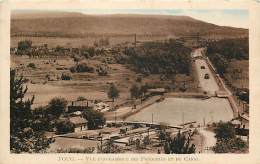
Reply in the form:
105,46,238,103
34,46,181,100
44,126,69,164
74,9,249,28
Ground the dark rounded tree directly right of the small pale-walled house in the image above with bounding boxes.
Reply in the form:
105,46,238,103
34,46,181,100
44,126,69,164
83,109,106,129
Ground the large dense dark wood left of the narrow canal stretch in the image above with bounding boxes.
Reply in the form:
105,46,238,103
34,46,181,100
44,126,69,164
125,39,191,75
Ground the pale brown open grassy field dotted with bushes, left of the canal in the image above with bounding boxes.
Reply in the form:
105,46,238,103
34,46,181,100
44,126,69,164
11,48,197,107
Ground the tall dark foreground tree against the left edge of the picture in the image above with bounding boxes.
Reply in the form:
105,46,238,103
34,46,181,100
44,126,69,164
10,70,52,153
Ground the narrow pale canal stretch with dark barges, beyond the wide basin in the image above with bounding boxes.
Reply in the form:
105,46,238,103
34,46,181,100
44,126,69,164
191,48,219,94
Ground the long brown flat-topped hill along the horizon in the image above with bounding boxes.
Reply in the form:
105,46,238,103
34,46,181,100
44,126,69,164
11,12,248,37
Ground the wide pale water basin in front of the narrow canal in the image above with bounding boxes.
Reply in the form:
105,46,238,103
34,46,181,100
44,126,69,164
126,97,233,125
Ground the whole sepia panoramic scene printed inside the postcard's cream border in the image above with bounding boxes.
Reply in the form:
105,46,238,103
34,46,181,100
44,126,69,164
10,10,249,154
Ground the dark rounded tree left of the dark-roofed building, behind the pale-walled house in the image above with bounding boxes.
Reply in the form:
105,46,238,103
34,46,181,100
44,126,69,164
47,97,68,118
